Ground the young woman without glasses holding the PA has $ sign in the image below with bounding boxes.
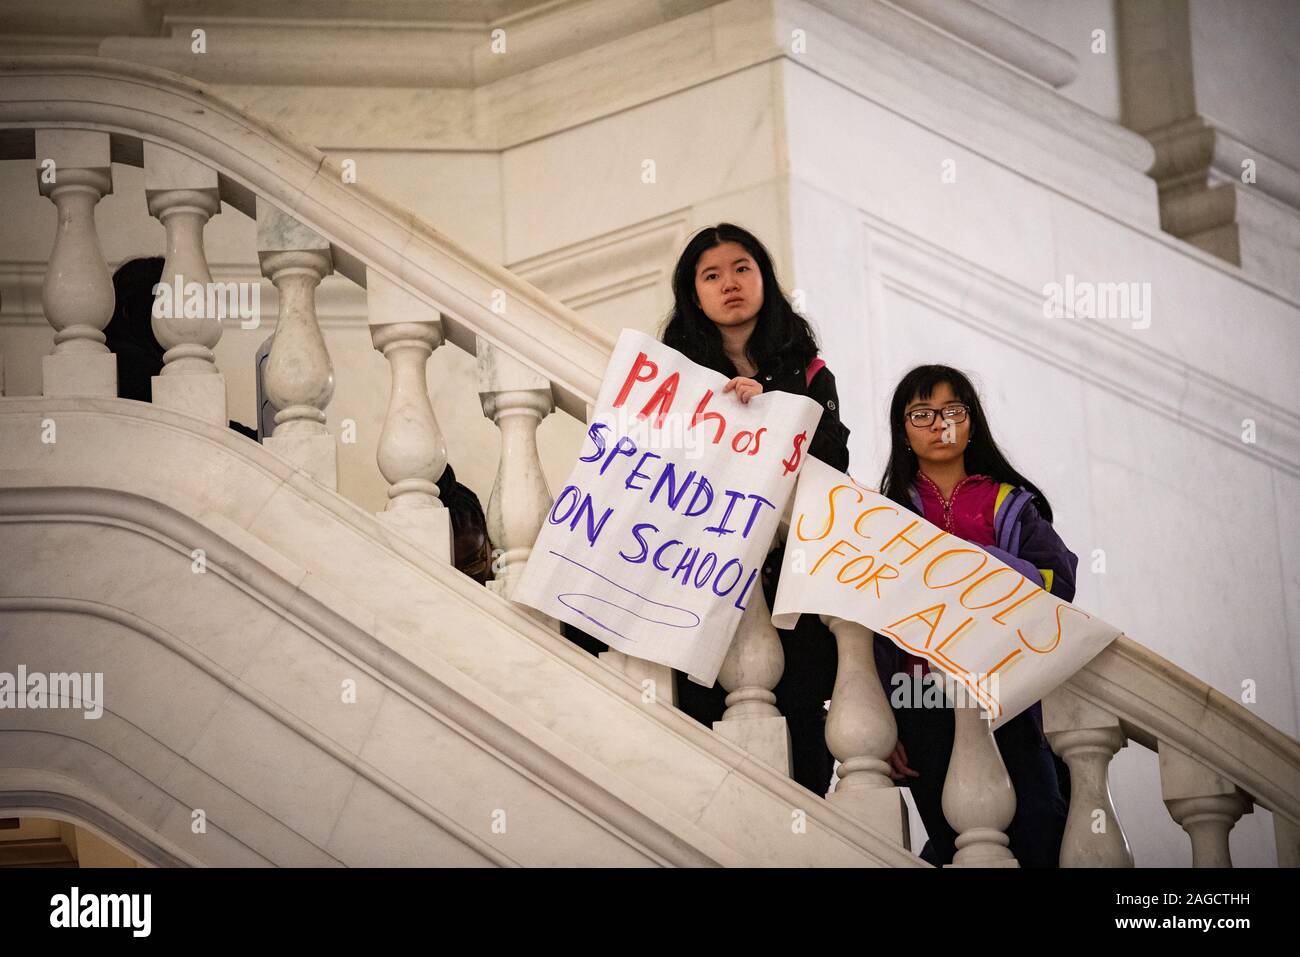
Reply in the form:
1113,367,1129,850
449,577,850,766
662,222,849,794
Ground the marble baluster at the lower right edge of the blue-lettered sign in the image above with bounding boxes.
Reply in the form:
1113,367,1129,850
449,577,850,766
714,579,790,787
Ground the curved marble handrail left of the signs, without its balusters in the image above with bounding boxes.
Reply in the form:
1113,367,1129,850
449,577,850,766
0,56,614,419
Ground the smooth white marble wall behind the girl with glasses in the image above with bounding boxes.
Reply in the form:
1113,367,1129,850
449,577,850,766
787,59,1300,865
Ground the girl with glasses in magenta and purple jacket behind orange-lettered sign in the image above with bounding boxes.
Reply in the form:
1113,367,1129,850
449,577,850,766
875,365,1079,867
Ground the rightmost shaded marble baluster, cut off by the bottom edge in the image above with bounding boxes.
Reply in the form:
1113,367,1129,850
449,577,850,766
1160,741,1253,867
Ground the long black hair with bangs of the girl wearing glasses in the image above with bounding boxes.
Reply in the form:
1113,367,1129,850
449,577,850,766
880,365,1052,521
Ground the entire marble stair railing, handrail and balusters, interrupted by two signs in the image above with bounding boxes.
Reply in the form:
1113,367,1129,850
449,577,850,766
0,57,1300,866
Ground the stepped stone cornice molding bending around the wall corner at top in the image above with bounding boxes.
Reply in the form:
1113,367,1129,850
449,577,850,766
0,0,1156,231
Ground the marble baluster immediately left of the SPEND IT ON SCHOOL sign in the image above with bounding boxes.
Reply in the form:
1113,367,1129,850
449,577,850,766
477,339,556,598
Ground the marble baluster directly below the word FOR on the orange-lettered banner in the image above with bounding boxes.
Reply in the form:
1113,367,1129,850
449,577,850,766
822,615,910,846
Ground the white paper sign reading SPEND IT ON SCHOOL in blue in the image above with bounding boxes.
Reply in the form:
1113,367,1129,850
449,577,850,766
511,330,822,685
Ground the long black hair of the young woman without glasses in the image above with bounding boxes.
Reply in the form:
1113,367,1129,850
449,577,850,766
659,222,818,377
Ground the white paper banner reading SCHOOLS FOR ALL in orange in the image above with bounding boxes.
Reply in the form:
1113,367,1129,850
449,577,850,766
772,459,1119,727
